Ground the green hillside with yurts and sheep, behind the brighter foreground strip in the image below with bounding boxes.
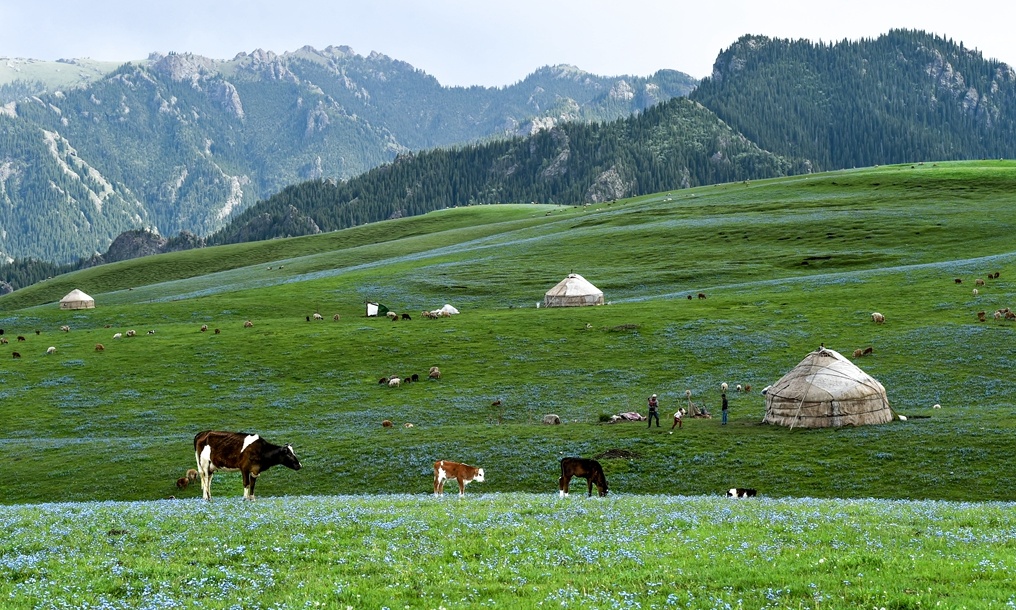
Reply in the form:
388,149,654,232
0,162,1016,503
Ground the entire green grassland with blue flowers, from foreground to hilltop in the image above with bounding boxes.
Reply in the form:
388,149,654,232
0,161,1016,608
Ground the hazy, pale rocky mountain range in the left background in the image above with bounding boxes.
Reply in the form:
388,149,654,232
0,47,695,262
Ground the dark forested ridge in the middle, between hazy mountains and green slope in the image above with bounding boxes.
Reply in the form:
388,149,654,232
209,98,807,244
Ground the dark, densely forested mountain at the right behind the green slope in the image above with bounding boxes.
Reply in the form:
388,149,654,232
691,29,1016,170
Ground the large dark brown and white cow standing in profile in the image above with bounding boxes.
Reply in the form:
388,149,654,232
194,430,301,500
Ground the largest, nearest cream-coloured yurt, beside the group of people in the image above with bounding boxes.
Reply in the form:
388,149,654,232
762,347,892,428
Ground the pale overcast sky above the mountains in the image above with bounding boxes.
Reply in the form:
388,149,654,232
0,0,1016,86
